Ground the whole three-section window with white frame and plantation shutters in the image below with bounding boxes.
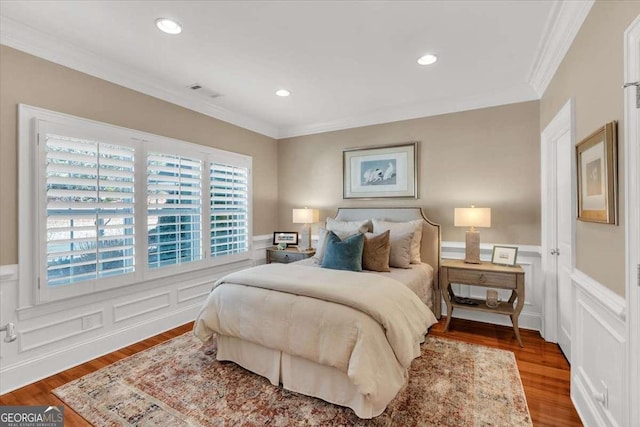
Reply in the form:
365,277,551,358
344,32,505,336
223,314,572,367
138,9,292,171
20,106,251,302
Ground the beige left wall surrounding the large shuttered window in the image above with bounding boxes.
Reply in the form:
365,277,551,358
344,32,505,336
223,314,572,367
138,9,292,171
0,46,278,265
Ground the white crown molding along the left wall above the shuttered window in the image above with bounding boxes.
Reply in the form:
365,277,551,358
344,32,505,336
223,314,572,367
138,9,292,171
0,16,278,138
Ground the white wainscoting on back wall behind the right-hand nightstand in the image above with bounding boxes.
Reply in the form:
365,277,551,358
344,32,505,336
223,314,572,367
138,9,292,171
442,242,544,331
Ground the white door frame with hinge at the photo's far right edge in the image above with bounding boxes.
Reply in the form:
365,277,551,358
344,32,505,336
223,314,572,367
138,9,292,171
624,16,640,427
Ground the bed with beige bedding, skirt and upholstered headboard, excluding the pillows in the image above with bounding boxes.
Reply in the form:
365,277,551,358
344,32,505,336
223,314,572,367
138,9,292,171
194,208,441,418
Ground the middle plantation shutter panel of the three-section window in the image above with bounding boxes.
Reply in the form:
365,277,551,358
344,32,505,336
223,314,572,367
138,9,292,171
147,153,202,268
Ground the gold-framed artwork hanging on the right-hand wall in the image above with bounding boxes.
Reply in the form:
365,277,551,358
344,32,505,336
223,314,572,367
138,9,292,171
576,121,618,224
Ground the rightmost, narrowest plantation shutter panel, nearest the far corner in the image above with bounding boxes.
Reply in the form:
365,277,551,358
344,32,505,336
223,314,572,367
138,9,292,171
209,162,249,257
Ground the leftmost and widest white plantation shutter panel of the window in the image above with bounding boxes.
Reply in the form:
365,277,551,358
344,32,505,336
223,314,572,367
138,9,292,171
44,133,135,286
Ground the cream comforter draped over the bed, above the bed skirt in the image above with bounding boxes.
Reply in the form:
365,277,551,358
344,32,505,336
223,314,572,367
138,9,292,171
194,264,436,410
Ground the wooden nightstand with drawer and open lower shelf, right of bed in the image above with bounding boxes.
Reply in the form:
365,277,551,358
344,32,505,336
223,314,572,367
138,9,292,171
440,259,524,347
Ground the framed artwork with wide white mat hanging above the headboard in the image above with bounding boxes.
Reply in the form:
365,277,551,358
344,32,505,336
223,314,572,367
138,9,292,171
342,142,418,199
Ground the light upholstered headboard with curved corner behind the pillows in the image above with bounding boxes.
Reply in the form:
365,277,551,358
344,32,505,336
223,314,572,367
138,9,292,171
335,208,442,319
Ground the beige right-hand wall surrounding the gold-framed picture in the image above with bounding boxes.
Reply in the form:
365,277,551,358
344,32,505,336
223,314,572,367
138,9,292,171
540,1,640,297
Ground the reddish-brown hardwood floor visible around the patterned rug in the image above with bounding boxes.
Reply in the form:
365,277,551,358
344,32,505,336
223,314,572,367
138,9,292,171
0,317,582,427
